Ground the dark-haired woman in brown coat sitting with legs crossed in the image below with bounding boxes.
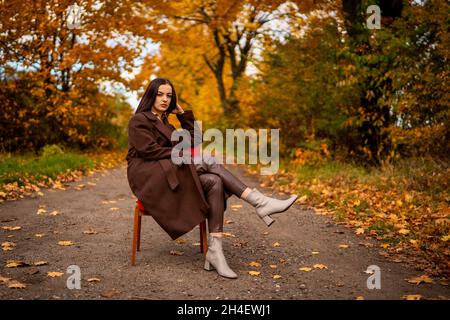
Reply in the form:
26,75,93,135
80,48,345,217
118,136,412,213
126,78,297,278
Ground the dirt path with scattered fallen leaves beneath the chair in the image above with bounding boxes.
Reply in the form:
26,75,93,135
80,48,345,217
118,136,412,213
0,166,450,299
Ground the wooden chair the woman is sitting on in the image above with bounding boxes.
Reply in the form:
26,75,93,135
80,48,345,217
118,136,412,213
131,200,208,266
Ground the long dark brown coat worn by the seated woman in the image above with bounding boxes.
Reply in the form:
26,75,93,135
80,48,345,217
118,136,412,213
126,110,211,239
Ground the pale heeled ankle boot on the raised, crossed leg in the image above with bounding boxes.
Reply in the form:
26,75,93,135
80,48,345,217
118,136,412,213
244,188,298,226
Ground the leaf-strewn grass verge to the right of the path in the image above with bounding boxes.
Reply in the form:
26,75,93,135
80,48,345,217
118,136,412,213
253,158,450,275
